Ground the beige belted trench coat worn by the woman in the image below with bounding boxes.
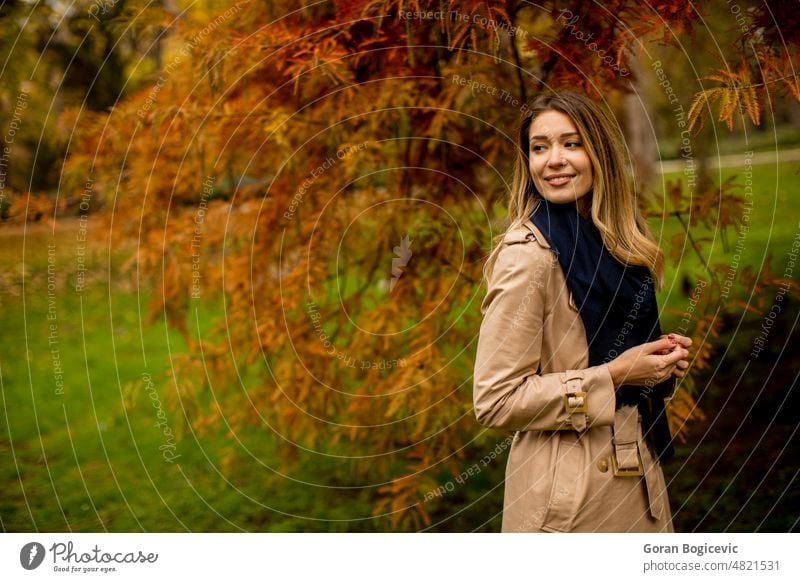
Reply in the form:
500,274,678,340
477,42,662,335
474,220,674,532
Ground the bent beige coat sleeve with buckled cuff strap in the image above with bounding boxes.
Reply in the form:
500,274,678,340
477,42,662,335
473,234,615,431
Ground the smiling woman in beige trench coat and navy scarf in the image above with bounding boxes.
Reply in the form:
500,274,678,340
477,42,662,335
474,92,691,532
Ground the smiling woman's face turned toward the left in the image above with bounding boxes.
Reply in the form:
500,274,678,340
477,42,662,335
528,110,593,204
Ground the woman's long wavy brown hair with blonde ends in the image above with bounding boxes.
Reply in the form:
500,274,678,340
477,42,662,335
483,91,664,289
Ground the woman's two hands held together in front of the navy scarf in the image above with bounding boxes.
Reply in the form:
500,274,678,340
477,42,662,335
608,334,692,387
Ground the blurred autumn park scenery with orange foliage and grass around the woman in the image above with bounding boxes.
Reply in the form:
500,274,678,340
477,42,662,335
0,0,800,532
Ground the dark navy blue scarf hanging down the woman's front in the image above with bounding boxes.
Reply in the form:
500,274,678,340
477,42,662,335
531,199,675,466
